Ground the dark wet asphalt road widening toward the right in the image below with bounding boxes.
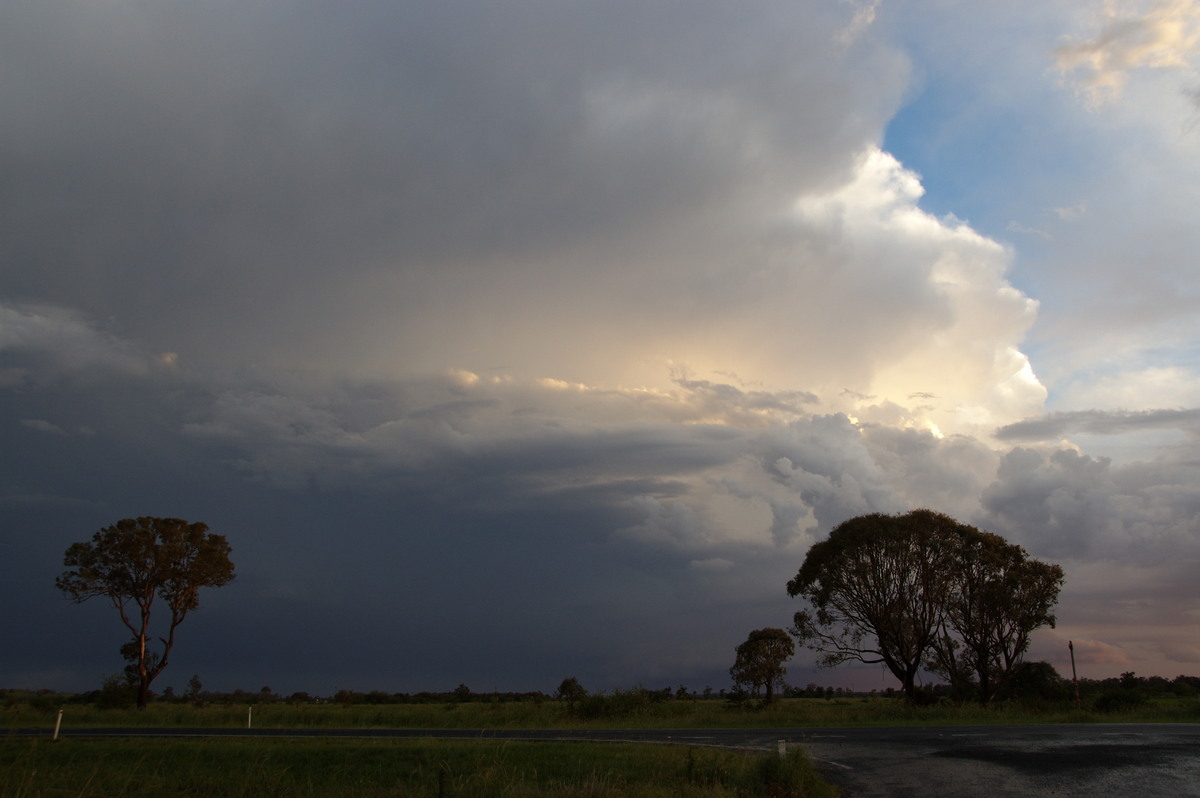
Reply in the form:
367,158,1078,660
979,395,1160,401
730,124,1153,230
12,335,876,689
16,724,1200,798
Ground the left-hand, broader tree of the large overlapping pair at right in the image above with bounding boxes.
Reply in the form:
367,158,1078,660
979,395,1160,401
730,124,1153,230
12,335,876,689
787,510,961,700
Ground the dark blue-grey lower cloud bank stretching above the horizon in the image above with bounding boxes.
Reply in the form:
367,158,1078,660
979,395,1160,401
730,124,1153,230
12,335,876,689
0,326,1198,692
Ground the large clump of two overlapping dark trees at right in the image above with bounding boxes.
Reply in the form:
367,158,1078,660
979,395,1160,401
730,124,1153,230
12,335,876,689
787,510,1063,702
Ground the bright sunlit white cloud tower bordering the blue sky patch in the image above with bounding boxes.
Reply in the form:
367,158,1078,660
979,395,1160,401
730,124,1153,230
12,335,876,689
797,150,1045,432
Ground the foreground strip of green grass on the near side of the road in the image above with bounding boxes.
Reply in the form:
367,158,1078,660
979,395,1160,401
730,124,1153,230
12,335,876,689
0,737,838,798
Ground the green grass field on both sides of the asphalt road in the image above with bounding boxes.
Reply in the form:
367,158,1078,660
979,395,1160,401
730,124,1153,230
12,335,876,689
0,691,1200,798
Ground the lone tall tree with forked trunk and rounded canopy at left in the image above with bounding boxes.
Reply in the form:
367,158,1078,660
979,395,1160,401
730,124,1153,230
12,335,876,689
55,517,234,709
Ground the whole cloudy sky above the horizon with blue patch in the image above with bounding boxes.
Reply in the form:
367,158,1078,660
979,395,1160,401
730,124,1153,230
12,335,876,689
0,0,1200,695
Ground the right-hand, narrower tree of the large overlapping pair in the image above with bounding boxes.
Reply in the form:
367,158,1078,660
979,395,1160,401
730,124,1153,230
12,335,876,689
928,526,1064,704
